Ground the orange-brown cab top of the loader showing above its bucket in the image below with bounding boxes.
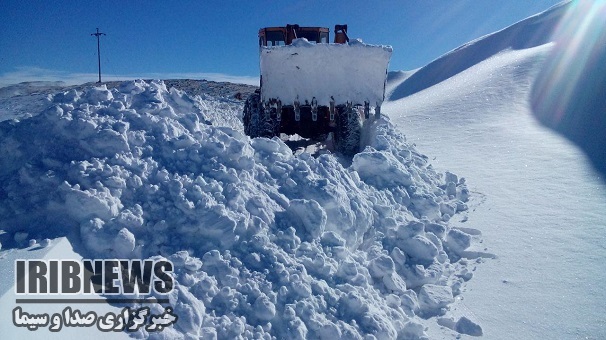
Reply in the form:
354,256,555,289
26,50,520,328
259,25,349,46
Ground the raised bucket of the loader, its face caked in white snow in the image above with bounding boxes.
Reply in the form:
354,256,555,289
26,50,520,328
260,38,392,106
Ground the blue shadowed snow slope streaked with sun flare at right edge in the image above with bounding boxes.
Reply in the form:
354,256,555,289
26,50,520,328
530,0,606,171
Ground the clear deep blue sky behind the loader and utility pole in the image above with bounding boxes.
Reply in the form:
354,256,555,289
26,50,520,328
0,0,560,86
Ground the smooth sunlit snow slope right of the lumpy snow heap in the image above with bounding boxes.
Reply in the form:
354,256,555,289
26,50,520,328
384,1,606,339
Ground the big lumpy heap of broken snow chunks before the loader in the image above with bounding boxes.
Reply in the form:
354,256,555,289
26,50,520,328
0,81,480,339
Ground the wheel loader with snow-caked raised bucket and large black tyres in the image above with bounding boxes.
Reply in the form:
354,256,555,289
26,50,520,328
242,25,392,155
